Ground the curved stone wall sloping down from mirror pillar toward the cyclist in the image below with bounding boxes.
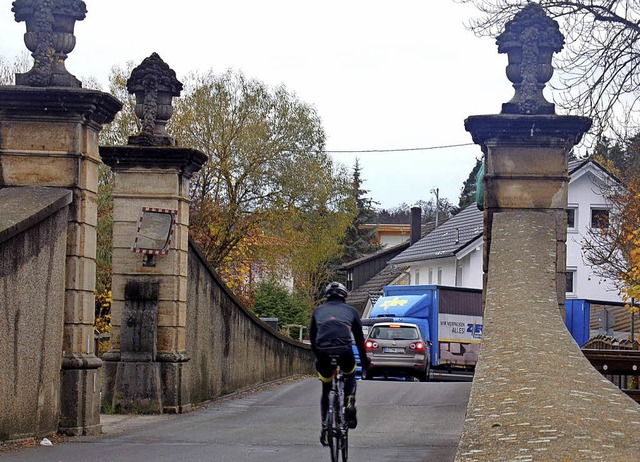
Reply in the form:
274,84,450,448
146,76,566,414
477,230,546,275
187,238,314,404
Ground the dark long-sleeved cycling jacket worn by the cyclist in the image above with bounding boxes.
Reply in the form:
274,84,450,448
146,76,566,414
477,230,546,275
309,299,366,357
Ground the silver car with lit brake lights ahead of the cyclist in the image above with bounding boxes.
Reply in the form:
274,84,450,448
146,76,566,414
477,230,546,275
364,322,430,382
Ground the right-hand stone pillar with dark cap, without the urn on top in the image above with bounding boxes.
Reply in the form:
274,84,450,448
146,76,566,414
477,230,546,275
465,114,590,312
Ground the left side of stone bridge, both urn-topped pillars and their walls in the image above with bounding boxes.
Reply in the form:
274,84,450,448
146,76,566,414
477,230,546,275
0,0,313,442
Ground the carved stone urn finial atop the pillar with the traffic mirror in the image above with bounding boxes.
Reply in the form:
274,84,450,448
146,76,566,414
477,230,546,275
127,53,182,146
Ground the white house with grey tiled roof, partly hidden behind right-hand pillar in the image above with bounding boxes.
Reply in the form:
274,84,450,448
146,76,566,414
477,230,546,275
389,159,621,302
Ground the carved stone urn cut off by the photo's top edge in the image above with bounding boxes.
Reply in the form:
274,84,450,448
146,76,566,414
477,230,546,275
11,0,87,88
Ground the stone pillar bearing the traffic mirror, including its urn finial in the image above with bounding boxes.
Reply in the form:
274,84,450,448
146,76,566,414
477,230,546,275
100,53,207,412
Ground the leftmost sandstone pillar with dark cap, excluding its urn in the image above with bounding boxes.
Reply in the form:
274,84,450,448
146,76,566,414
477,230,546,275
0,86,121,435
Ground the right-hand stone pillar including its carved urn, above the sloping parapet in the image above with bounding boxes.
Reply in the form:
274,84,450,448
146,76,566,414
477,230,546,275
465,3,591,313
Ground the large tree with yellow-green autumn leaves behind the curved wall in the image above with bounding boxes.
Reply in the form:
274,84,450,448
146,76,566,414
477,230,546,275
168,71,352,302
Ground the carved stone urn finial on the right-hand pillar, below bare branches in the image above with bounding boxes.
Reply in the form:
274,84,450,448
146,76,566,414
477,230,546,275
496,3,564,114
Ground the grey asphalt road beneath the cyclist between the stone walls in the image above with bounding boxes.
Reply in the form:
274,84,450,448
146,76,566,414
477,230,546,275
0,378,471,462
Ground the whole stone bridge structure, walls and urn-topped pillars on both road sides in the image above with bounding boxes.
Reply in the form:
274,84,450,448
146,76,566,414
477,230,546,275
0,0,640,461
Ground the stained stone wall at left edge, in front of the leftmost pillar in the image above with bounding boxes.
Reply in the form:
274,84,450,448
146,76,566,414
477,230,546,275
0,187,72,442
